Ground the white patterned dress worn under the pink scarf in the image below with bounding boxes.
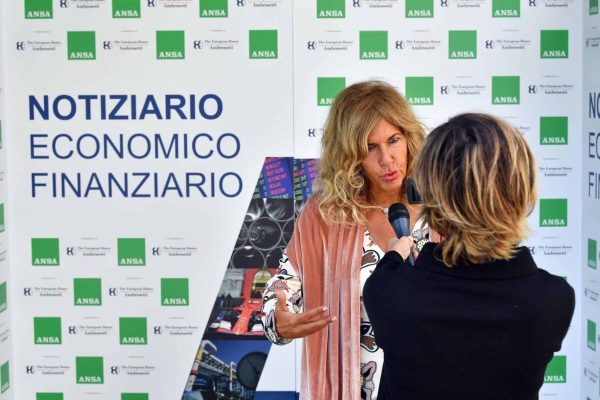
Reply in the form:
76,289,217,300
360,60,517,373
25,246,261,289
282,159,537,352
262,220,429,400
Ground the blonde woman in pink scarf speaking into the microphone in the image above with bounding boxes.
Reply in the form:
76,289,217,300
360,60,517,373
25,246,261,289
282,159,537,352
263,81,428,400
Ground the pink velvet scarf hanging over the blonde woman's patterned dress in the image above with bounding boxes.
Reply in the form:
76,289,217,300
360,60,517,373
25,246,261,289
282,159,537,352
288,198,365,400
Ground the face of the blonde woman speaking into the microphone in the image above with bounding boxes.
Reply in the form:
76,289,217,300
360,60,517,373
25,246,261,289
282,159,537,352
360,118,408,200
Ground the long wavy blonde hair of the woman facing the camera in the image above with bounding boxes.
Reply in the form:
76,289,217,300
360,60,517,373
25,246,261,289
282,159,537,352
316,81,425,225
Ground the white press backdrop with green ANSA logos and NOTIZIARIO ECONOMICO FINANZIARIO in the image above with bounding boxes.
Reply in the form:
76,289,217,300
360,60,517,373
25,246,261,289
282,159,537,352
0,0,600,400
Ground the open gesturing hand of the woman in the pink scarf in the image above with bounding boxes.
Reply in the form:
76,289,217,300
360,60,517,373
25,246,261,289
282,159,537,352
275,290,337,339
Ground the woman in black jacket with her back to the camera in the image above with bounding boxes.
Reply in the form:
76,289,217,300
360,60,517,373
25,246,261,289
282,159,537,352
364,114,575,400
